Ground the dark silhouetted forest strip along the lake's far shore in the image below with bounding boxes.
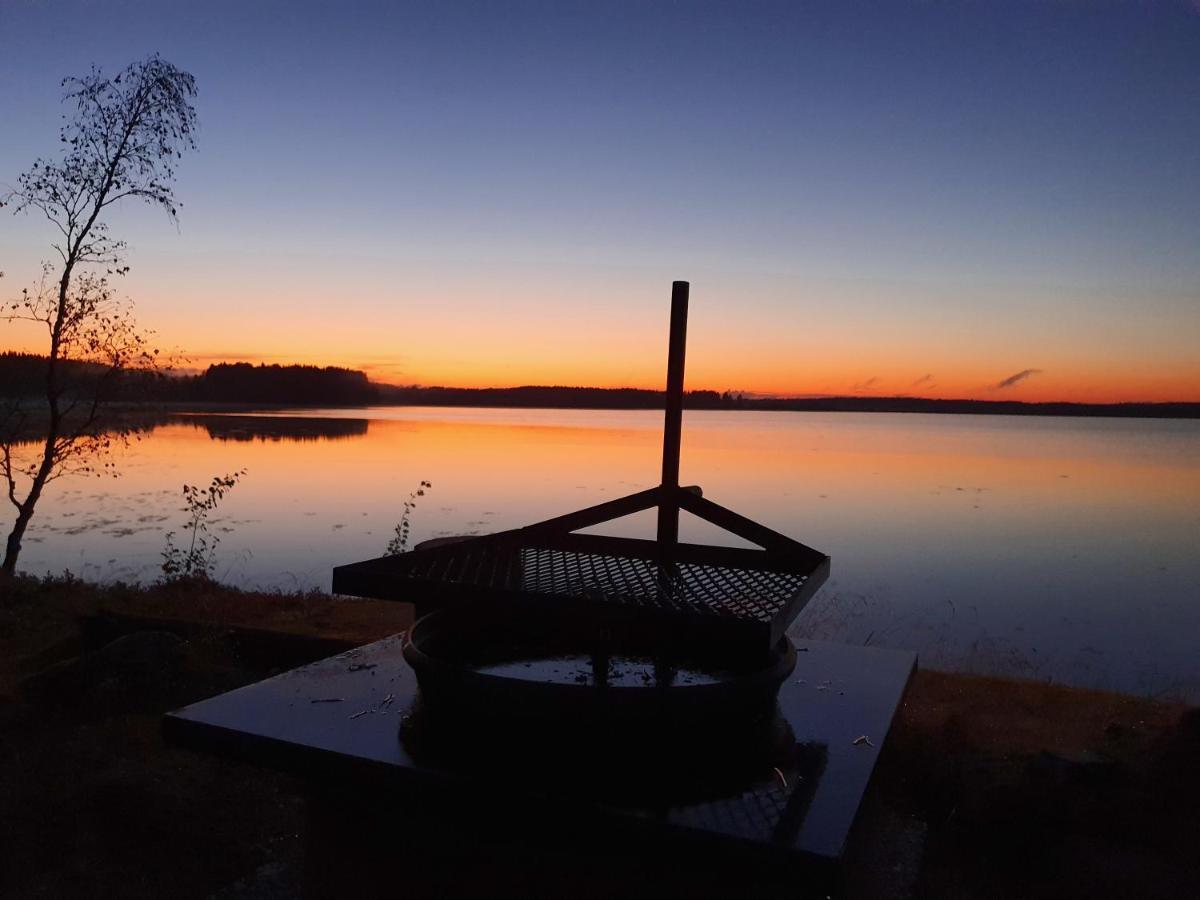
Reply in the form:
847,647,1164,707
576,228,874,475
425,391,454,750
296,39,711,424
0,352,1200,419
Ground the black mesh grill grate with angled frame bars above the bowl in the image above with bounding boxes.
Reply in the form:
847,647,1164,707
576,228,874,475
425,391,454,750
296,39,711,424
332,487,829,653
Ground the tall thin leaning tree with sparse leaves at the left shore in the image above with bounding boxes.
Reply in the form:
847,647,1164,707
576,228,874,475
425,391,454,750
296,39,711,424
0,55,196,576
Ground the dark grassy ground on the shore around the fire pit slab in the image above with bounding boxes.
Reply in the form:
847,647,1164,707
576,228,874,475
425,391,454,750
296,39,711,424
0,581,1200,900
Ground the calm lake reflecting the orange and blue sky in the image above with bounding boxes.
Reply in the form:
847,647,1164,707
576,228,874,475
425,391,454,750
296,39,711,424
5,407,1200,701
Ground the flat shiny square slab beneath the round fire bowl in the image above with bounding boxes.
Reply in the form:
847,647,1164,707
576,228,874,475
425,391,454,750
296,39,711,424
164,637,917,887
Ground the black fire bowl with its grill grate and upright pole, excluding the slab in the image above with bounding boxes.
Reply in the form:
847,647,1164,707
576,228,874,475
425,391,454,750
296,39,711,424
334,282,829,787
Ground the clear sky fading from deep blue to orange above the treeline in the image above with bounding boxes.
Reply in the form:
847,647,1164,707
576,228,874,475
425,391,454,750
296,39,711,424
0,0,1200,401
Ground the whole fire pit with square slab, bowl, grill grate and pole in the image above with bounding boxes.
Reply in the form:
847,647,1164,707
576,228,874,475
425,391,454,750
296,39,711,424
164,282,916,895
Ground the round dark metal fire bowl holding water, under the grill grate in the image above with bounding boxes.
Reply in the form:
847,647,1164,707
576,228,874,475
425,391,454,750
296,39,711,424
402,606,796,797
